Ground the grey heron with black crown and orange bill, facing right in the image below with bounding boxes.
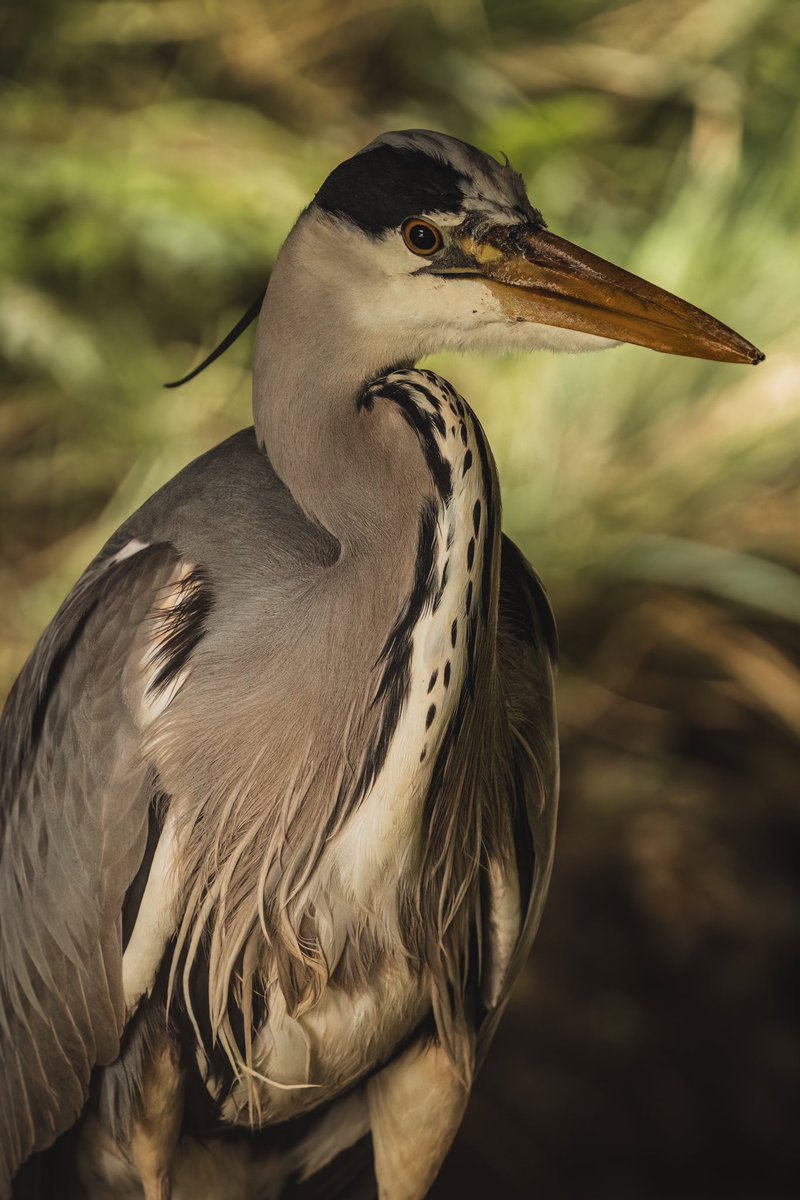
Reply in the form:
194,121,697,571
0,130,764,1200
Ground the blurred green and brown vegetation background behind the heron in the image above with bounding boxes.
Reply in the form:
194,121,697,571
0,0,800,1200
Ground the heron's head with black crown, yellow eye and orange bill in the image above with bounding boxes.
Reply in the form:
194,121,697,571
304,130,764,364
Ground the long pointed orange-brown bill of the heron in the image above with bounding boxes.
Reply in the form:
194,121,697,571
464,226,764,365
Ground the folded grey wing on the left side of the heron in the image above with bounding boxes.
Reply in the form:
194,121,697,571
0,542,210,1196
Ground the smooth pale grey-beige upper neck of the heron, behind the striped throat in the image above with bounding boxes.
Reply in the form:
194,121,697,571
253,217,417,545
